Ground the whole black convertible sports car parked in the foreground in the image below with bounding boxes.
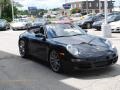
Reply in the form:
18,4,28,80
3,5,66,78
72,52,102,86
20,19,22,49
19,23,118,72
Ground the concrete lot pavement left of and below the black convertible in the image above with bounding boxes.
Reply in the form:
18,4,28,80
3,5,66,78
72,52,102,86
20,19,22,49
0,31,120,90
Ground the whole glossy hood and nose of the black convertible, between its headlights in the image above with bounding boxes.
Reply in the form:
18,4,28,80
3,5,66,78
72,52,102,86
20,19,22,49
53,35,111,58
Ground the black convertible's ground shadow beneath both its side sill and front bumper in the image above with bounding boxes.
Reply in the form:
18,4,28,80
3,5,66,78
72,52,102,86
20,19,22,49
26,56,120,79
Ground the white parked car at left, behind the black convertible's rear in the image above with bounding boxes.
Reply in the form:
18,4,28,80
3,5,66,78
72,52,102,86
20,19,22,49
10,19,31,30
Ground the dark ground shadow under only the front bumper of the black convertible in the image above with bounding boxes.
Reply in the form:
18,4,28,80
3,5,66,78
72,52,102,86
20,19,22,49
62,64,120,79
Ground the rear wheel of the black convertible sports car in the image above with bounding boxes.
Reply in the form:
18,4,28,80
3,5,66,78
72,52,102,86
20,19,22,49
19,40,29,58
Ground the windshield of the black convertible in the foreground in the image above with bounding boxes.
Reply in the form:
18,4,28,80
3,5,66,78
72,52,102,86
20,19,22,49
47,24,86,38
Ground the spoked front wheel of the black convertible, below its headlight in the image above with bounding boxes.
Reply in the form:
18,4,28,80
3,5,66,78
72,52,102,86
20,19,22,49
49,50,63,73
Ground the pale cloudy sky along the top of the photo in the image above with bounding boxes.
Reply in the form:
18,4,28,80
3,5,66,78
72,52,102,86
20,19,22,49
14,0,120,9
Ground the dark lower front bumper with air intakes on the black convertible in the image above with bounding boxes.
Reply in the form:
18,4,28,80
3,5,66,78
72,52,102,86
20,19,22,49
75,54,118,69
